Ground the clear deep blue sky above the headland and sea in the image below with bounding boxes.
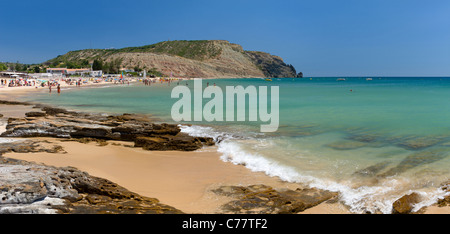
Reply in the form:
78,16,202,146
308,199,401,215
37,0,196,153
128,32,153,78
0,0,450,76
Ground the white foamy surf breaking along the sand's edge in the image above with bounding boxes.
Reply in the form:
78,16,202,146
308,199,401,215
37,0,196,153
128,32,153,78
180,125,450,214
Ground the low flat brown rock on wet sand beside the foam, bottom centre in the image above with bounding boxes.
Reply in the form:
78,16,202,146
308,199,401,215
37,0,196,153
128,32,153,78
213,185,338,214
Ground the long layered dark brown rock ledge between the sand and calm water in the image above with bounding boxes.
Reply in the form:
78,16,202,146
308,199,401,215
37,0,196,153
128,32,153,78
1,103,214,151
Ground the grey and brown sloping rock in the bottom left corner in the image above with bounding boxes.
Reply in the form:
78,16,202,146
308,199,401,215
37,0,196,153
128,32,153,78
0,157,182,214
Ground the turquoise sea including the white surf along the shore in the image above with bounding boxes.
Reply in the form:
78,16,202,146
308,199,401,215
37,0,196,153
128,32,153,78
25,77,450,213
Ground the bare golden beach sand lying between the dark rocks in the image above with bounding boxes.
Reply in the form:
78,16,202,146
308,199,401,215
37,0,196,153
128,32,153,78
0,80,450,214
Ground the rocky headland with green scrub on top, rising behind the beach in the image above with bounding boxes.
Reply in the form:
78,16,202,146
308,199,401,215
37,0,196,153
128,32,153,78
46,40,297,78
